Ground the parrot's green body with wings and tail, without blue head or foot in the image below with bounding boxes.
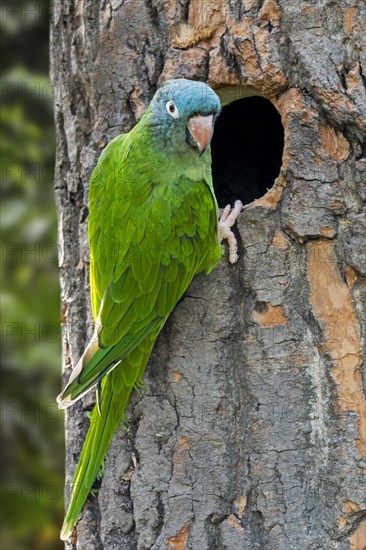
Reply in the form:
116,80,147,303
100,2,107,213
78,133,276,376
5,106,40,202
59,126,221,539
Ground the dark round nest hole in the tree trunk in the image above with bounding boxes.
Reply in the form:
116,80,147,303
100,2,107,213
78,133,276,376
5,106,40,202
211,96,284,207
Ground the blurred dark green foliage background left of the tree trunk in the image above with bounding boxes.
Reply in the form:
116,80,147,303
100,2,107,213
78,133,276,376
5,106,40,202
0,0,64,550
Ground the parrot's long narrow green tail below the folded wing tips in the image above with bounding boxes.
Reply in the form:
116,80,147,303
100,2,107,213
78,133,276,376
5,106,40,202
60,334,156,540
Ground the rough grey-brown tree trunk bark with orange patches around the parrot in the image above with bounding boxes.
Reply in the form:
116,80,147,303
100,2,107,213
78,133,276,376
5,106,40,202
52,0,366,550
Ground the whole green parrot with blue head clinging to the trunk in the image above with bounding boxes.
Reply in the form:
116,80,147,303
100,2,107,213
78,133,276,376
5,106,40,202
57,79,242,540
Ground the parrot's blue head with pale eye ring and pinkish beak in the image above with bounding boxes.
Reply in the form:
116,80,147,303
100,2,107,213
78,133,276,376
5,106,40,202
148,79,220,155
